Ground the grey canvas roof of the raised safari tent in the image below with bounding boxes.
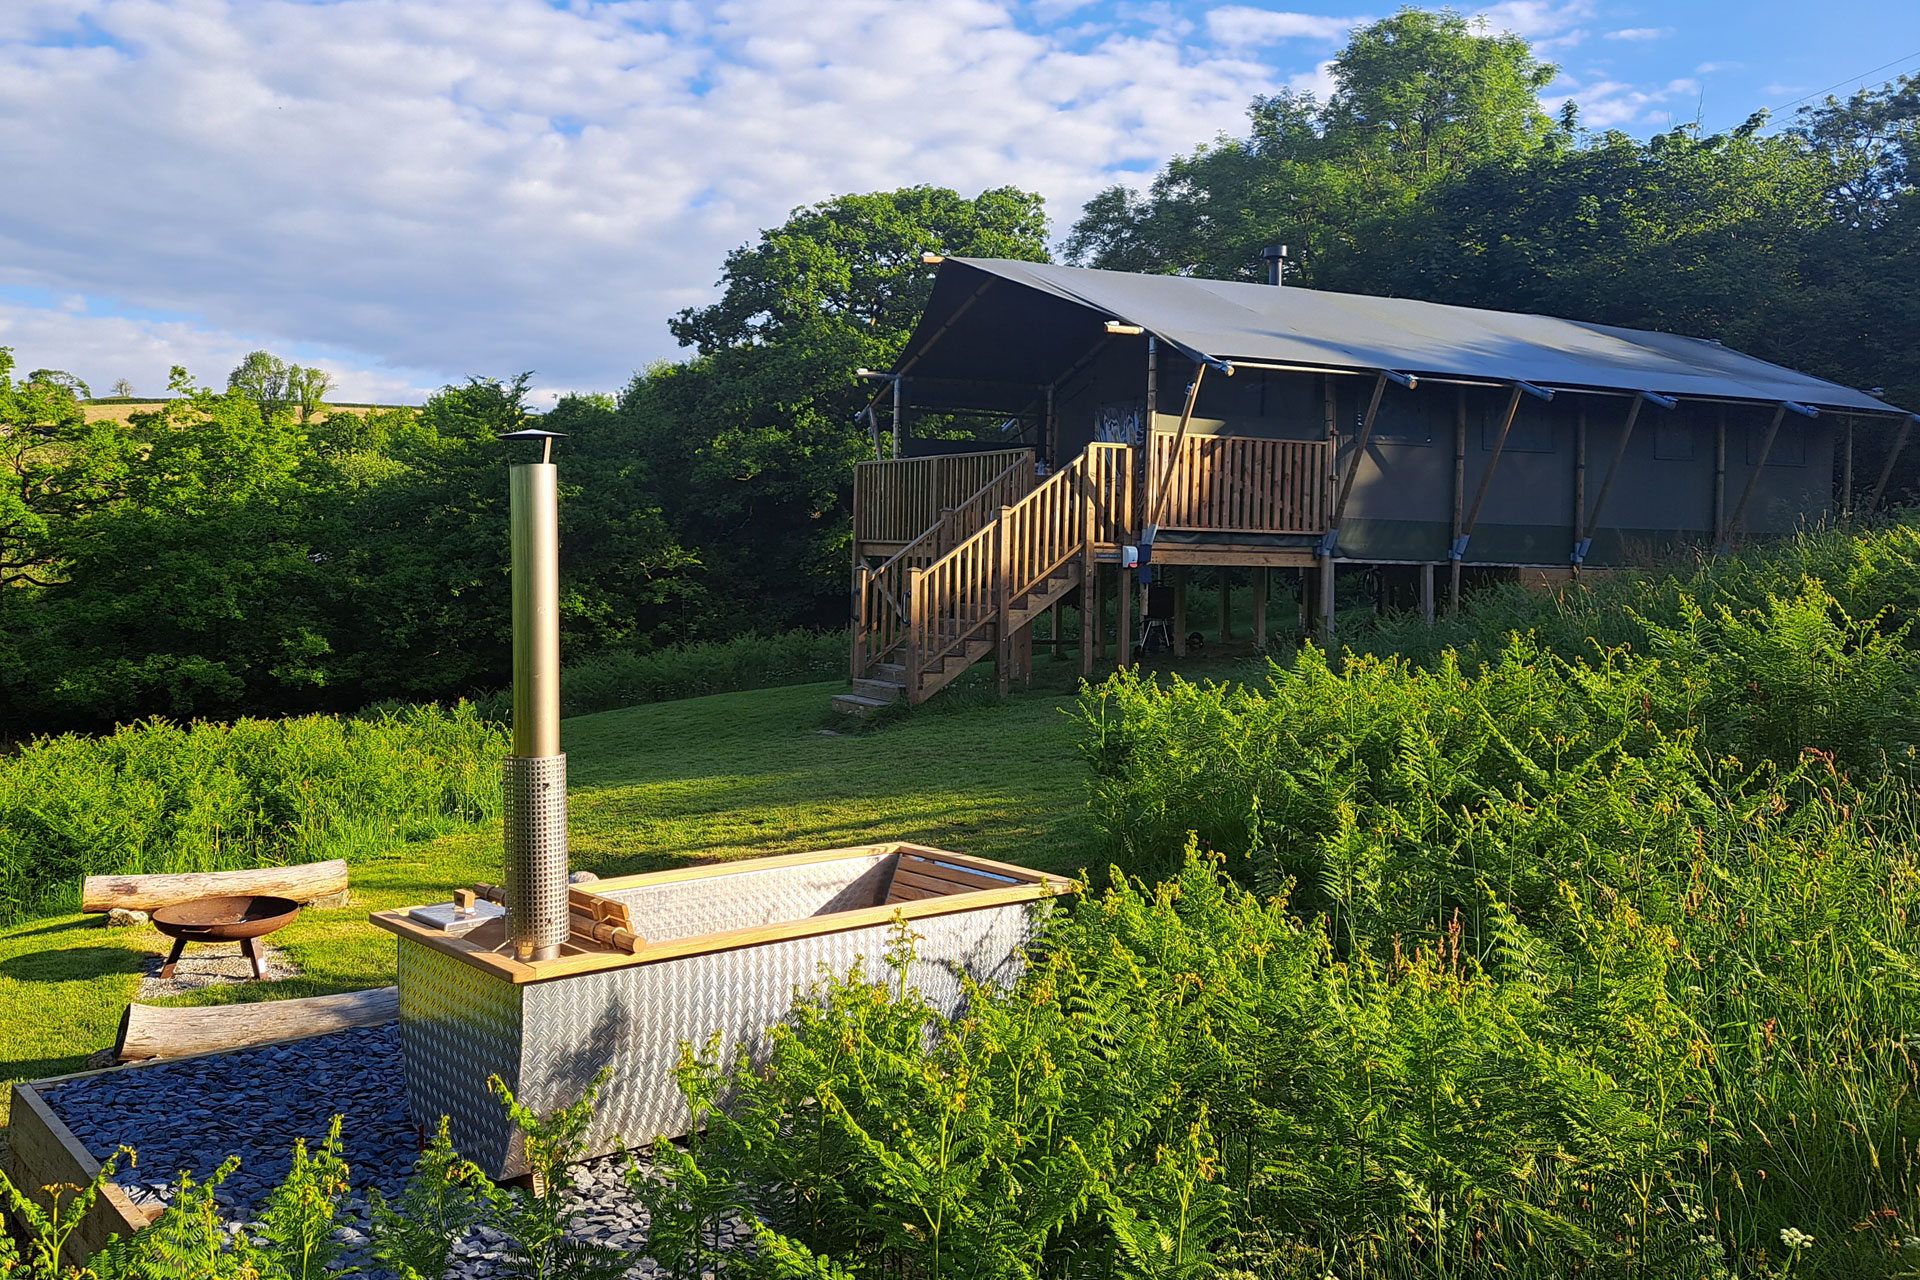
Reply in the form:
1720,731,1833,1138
900,257,1901,415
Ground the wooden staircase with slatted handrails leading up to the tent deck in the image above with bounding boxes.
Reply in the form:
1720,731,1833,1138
833,445,1131,716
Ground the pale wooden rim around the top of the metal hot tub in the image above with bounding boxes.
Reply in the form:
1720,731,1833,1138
369,842,1073,986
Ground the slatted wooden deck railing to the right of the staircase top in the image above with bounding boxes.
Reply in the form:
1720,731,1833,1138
1142,434,1331,533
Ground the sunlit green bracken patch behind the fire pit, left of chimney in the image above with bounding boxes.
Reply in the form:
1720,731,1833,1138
0,702,507,919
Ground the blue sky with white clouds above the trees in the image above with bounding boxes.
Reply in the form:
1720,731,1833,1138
0,0,1920,407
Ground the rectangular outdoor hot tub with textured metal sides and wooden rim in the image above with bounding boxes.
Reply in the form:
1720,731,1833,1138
372,844,1069,1176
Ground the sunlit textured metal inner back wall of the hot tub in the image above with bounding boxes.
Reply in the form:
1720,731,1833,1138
597,854,897,942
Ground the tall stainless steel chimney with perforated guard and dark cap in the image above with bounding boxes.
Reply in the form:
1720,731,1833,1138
501,430,568,960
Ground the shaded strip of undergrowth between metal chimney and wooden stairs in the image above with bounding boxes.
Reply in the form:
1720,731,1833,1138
468,631,847,720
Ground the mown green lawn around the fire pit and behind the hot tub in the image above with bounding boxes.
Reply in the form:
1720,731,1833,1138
0,664,1152,1105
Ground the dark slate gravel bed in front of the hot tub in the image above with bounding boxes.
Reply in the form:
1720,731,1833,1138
44,1023,745,1280
